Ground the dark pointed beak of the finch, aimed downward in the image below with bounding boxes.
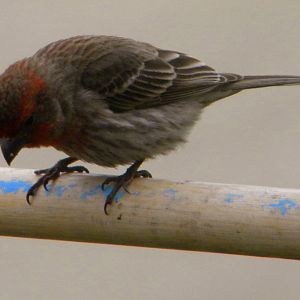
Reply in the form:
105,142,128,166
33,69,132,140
0,132,28,165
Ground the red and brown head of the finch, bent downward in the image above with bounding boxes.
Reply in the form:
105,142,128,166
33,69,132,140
0,60,58,164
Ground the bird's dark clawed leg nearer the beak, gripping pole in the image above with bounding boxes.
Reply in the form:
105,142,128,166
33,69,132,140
26,157,89,204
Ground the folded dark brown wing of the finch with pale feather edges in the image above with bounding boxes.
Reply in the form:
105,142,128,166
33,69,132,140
81,48,241,112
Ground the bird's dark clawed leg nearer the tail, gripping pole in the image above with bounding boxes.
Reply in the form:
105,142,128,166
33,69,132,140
102,160,152,215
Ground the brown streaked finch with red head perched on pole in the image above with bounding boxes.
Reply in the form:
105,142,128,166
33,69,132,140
0,35,300,214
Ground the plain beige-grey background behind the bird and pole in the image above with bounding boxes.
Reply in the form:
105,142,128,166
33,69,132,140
0,0,300,300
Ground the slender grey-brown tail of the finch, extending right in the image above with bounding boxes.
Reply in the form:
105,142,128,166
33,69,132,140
222,74,300,90
